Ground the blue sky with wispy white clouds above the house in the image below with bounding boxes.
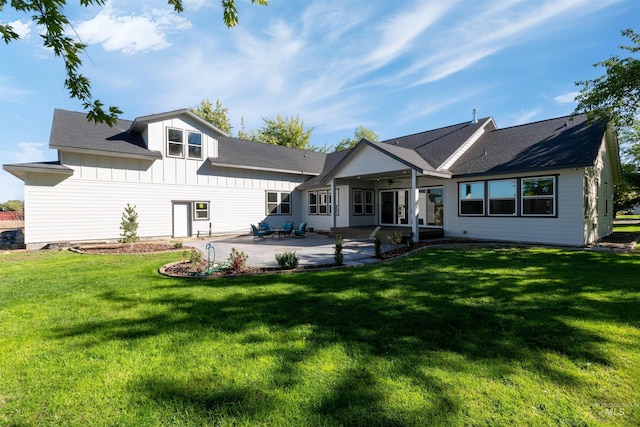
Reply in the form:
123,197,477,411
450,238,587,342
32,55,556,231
0,0,640,202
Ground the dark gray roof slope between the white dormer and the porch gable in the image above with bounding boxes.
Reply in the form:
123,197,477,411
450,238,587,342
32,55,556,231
209,137,327,175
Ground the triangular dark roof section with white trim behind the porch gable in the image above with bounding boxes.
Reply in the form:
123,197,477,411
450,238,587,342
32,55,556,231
381,117,493,169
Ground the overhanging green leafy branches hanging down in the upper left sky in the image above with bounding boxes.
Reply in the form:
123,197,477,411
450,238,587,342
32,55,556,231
0,0,268,126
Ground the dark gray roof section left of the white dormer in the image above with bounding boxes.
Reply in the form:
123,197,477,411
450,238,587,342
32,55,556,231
49,109,162,159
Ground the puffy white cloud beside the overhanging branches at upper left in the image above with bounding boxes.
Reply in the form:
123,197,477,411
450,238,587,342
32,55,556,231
75,1,191,54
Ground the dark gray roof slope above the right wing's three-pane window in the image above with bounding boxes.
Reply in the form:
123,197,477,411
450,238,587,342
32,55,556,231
449,114,605,176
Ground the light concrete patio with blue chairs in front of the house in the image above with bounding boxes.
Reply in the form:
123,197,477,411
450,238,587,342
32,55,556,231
185,233,391,267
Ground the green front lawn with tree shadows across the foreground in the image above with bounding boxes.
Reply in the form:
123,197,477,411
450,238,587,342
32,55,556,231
0,248,640,426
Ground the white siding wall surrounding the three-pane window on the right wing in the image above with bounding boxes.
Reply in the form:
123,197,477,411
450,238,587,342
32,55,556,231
444,168,584,246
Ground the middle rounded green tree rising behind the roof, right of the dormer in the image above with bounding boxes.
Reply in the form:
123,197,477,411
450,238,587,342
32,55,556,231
251,114,314,150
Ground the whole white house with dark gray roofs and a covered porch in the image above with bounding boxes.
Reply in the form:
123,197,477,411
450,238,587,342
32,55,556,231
3,110,621,248
